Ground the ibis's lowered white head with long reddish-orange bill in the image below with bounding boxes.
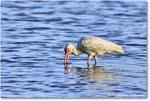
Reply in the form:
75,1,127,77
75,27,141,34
64,43,74,64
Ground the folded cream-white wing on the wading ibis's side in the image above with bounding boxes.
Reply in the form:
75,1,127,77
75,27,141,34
82,37,120,55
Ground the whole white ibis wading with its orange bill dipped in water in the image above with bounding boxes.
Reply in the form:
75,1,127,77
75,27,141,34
64,36,124,64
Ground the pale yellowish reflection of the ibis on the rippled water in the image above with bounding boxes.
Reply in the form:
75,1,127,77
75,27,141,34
64,64,121,84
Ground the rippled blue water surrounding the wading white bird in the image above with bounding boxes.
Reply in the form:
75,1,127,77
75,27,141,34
1,0,147,98
